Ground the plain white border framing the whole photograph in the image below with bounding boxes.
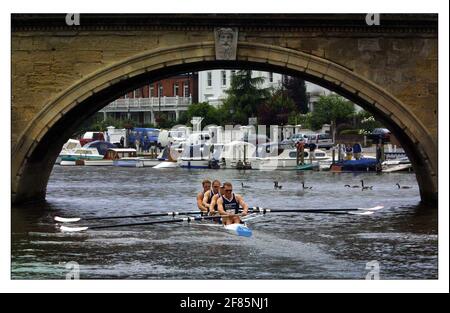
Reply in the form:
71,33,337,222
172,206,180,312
0,0,449,293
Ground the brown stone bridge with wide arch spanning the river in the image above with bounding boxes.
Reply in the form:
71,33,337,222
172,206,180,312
11,14,438,203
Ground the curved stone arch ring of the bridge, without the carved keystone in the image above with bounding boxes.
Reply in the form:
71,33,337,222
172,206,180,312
11,42,437,203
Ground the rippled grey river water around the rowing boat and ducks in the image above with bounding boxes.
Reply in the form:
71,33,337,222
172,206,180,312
11,166,438,279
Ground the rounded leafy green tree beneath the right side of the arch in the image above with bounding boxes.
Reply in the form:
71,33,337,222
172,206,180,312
311,94,355,129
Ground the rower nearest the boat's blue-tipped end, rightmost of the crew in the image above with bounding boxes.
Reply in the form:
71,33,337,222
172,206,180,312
217,182,248,225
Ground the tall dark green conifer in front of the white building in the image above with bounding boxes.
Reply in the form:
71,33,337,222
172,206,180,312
221,70,270,125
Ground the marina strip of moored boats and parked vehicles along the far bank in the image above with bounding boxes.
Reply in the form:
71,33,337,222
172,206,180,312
55,126,413,173
